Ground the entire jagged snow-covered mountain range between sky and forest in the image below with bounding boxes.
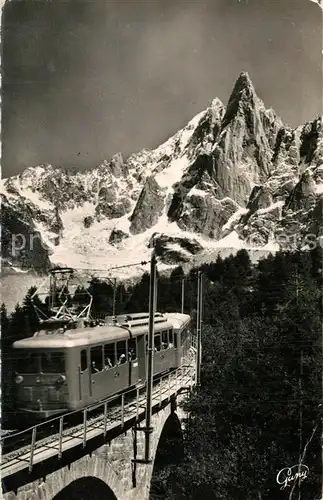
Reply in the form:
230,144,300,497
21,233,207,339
1,73,323,278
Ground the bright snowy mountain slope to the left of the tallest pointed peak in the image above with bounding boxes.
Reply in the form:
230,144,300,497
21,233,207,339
1,94,228,274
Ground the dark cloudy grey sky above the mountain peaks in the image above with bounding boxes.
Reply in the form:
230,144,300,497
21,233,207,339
2,0,322,176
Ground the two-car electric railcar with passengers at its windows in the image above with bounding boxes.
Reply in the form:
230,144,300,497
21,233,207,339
13,313,191,420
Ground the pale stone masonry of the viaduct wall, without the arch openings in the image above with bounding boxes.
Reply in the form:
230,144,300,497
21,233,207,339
3,396,189,500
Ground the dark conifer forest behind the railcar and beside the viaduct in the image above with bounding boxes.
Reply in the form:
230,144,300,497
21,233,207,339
1,249,322,500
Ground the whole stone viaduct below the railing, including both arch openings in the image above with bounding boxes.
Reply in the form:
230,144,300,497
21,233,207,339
2,372,194,500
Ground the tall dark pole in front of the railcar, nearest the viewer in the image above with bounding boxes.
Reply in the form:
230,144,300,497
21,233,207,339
144,249,157,462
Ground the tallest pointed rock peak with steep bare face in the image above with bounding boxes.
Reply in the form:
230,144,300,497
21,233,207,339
168,73,282,239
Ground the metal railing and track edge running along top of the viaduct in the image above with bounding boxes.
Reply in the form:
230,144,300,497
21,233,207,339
0,363,195,472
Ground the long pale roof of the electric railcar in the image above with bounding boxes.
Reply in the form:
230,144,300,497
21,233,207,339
13,313,190,349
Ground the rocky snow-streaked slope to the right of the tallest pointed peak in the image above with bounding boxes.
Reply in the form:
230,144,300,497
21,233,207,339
236,118,323,250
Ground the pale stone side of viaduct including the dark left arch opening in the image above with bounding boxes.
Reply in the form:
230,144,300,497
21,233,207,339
3,396,186,500
